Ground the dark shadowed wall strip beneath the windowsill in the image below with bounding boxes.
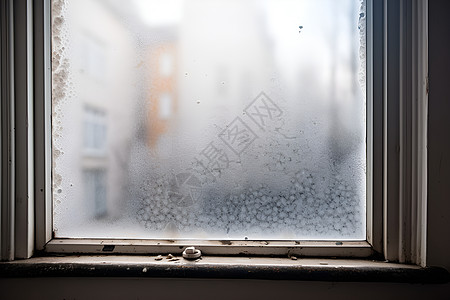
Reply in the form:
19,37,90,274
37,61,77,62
0,278,450,300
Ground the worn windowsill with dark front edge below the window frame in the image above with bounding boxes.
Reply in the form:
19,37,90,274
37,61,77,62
0,255,450,283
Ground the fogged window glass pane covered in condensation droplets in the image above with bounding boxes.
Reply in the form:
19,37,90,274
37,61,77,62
52,0,366,240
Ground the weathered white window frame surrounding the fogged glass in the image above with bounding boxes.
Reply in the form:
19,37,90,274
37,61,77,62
0,0,428,266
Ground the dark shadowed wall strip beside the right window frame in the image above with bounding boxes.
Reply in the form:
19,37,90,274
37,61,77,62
427,0,450,272
